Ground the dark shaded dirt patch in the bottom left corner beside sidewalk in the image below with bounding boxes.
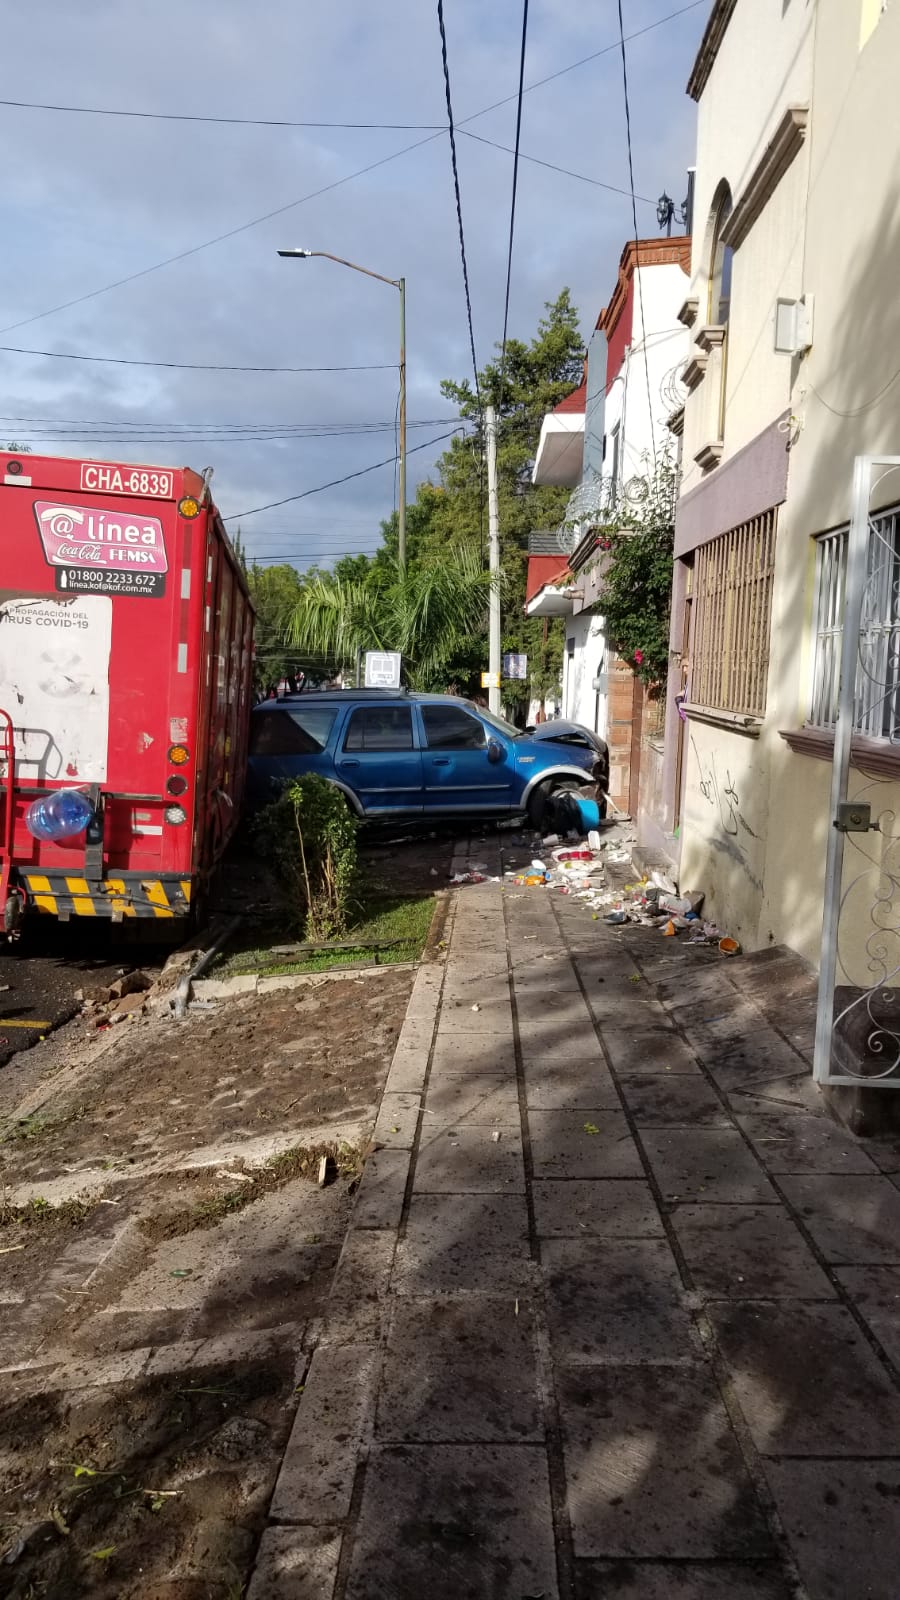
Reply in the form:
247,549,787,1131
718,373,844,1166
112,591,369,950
0,1354,298,1600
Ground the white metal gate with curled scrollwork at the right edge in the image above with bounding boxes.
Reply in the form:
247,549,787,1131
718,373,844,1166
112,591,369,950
812,456,900,1088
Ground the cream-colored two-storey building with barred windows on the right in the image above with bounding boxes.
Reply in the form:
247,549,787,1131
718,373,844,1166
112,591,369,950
653,0,900,962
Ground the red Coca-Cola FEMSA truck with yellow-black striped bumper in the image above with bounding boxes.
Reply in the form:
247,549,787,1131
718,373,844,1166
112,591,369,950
0,451,253,934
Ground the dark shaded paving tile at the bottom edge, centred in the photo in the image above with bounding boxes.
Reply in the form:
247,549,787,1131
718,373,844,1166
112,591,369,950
346,1445,559,1600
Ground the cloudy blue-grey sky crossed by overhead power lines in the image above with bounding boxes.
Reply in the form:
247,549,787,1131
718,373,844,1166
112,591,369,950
0,0,701,568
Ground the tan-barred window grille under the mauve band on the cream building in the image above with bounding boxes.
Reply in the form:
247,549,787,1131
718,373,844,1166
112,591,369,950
689,510,777,717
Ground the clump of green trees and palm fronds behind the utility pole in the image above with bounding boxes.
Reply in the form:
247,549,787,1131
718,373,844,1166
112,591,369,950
283,290,585,704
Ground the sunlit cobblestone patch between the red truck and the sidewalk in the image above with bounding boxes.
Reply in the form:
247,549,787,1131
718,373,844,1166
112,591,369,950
0,970,413,1186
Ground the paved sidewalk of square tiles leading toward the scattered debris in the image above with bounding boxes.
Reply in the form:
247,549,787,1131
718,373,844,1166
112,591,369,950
250,842,900,1600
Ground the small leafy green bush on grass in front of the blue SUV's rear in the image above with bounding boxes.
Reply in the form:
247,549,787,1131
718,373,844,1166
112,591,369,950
256,773,357,941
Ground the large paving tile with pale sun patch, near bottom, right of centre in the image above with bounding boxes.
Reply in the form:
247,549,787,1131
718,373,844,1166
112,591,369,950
557,1366,770,1555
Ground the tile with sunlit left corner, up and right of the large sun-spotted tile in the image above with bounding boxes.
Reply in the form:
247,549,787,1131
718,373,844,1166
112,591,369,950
708,1301,900,1456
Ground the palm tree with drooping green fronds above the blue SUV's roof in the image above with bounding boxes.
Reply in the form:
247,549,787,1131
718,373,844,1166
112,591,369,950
287,547,490,688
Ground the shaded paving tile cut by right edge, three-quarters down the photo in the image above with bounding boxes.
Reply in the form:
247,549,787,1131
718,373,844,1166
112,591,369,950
780,1174,900,1267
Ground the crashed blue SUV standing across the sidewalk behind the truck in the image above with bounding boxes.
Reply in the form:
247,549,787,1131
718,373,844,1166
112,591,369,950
250,690,597,826
